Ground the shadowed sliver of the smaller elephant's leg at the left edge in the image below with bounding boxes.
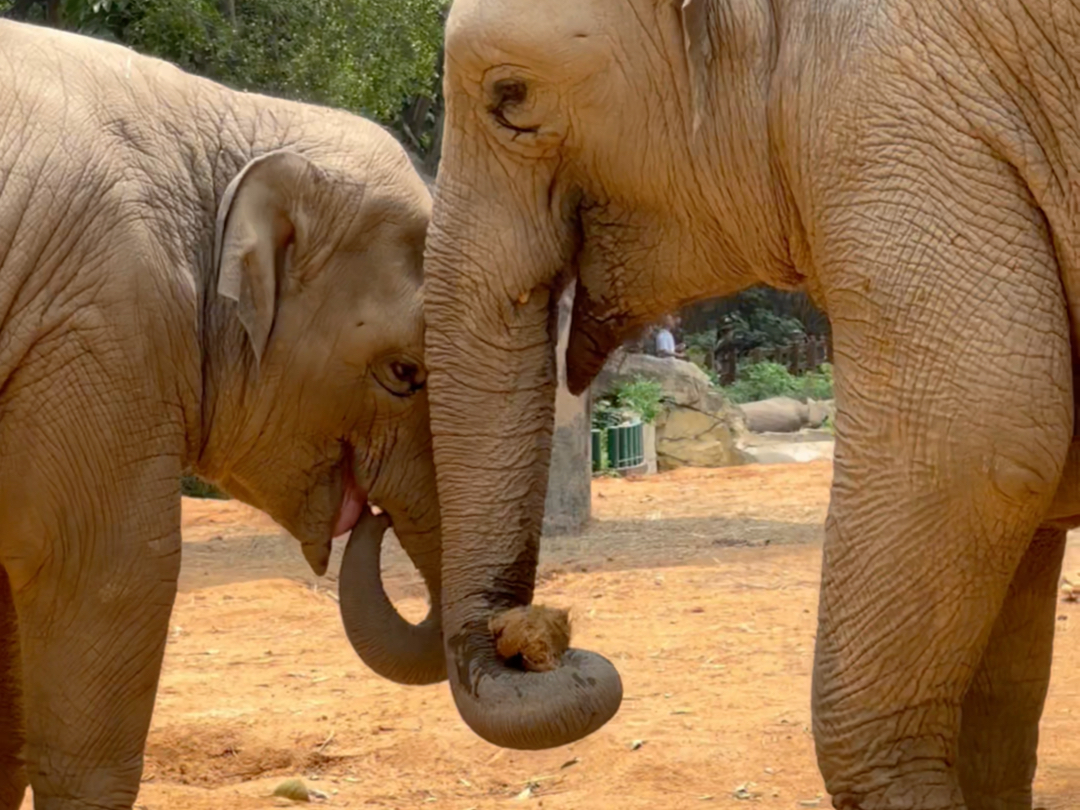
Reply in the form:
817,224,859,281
0,566,27,810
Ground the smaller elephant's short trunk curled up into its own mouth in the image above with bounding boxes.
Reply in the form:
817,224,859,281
339,507,446,685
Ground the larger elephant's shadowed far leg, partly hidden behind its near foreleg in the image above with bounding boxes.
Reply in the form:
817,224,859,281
959,527,1066,810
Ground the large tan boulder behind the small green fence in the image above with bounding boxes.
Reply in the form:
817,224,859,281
592,352,753,470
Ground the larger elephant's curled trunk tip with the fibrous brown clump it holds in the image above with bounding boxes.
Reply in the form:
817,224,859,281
446,605,622,751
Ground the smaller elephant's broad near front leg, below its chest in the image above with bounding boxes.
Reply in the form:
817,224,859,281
12,479,180,810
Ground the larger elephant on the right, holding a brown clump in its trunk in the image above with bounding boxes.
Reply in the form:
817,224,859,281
424,0,1080,810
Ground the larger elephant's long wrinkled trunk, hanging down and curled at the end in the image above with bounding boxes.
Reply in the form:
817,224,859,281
424,195,622,750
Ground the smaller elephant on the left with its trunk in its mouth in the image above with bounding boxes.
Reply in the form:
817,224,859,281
0,22,445,810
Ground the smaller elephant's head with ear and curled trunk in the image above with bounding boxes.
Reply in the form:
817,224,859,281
195,142,446,684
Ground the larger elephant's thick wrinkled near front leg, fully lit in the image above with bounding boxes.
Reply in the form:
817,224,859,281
812,147,1074,810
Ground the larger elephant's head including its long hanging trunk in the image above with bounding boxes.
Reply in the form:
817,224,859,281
424,0,800,747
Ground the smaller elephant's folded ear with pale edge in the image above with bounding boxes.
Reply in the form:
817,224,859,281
214,150,319,367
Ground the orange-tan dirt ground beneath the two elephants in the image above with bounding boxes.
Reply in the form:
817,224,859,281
25,462,1080,810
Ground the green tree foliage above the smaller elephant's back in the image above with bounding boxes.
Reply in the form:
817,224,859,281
8,0,448,135
